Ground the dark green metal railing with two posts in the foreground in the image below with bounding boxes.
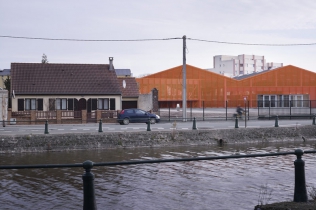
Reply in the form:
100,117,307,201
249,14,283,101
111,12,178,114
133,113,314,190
0,149,316,210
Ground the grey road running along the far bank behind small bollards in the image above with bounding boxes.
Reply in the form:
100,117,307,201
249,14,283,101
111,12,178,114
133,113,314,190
0,119,316,135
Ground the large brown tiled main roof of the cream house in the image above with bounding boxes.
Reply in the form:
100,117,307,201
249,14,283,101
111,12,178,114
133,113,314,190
11,63,121,95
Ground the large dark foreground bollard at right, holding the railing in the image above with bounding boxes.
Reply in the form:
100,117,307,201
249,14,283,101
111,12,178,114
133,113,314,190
294,149,307,202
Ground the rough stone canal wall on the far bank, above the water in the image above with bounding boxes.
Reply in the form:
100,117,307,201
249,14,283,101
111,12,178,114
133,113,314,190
0,125,316,153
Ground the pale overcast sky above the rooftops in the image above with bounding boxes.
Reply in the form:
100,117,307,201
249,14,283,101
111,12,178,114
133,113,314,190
0,0,316,76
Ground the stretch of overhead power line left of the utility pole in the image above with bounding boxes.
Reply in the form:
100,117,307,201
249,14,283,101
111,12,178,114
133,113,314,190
0,35,182,42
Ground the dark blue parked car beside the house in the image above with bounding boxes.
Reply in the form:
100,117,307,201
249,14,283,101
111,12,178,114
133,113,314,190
117,109,160,125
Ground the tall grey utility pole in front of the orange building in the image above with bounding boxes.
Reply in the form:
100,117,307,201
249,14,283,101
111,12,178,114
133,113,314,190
182,35,187,121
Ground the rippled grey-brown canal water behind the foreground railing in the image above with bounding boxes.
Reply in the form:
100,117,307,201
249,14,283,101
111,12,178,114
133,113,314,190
0,142,316,210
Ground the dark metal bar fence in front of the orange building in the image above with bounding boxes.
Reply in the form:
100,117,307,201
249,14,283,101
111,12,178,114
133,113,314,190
157,100,316,121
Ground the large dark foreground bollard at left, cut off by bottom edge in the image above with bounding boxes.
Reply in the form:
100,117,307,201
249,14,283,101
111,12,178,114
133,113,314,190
82,160,97,210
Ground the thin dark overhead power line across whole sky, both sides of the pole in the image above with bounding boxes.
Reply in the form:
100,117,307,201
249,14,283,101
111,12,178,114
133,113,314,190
0,35,316,47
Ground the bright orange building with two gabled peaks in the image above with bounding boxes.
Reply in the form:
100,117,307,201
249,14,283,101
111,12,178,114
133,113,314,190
136,65,316,108
